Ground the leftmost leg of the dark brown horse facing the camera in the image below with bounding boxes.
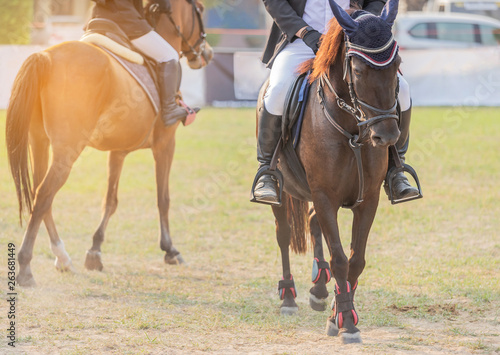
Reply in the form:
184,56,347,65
272,197,299,315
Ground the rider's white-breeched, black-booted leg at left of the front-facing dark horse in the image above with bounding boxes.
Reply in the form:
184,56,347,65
254,40,314,204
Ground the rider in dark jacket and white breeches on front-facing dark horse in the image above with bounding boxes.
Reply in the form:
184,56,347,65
254,0,419,205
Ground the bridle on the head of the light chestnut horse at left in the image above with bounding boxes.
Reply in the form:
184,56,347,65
149,0,209,63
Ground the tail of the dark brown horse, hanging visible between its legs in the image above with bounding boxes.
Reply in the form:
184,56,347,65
285,194,310,254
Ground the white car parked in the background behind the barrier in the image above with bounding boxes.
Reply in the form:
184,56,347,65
393,11,500,49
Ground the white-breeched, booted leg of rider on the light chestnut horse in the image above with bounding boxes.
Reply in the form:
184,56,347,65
132,31,187,126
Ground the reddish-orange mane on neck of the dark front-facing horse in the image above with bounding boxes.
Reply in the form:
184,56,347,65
298,9,356,83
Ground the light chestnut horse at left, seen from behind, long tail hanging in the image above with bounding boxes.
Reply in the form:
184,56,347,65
6,0,212,286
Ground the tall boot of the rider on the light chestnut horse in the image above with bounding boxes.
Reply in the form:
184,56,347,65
157,60,187,126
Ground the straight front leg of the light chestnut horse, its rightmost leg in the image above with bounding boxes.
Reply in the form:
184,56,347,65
153,132,185,265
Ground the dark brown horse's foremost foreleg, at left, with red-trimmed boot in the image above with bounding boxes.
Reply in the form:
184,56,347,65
313,192,361,344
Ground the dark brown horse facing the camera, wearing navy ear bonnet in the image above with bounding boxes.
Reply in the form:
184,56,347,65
266,0,400,343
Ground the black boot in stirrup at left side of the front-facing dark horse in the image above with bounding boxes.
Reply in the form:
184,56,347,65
254,104,281,204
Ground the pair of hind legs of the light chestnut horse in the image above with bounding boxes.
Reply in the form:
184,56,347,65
17,147,81,287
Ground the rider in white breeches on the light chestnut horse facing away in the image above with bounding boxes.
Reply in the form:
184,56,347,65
92,0,188,126
